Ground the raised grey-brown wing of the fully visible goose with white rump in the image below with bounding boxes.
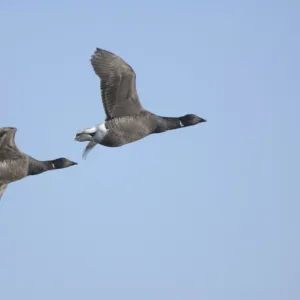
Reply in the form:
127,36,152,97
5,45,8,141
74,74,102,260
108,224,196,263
91,48,143,120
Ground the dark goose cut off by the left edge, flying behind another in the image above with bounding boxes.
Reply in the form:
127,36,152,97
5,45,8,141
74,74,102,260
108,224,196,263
0,127,77,199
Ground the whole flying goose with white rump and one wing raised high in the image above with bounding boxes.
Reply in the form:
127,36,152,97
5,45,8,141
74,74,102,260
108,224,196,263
74,48,206,158
